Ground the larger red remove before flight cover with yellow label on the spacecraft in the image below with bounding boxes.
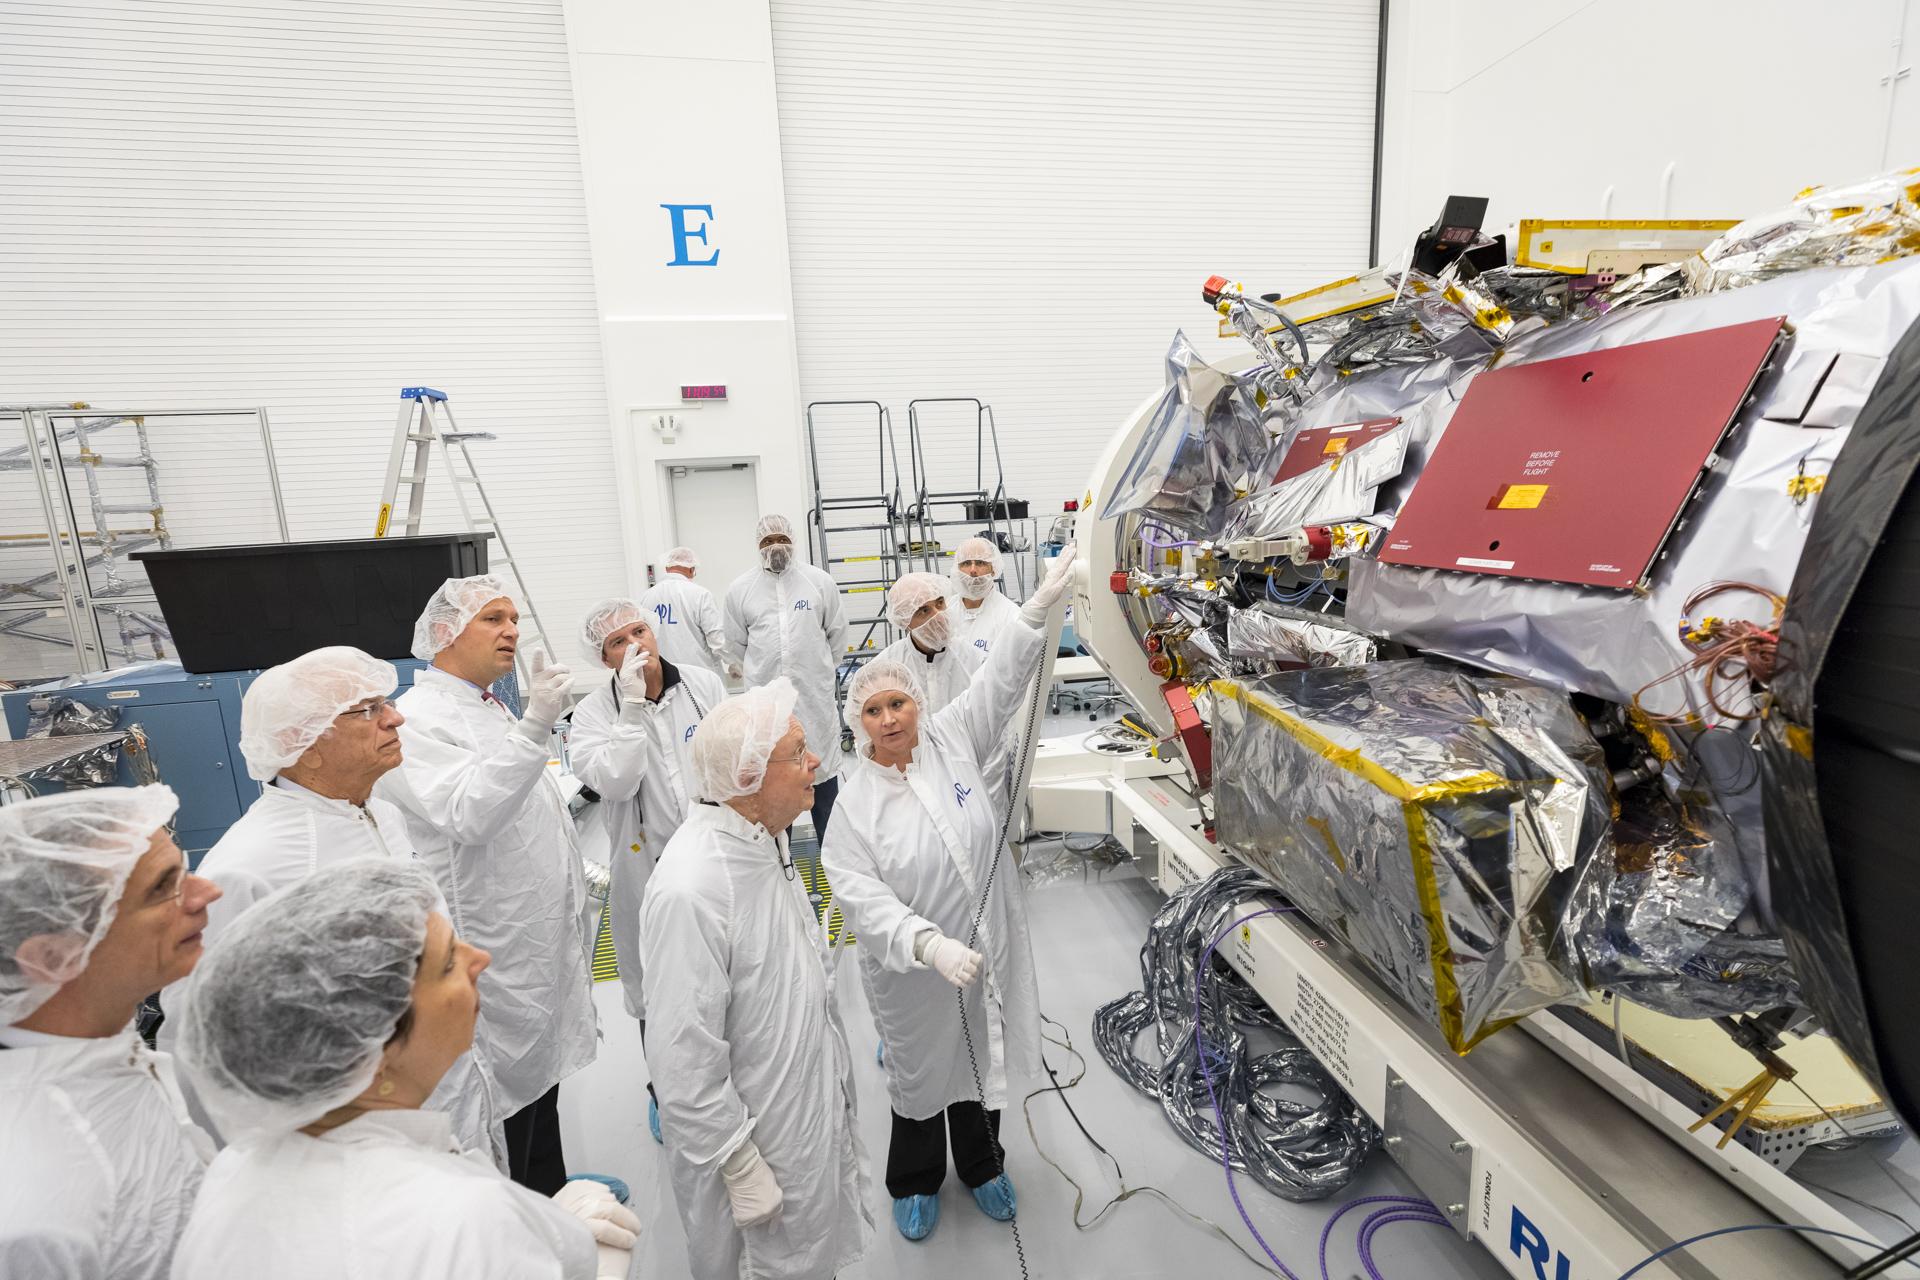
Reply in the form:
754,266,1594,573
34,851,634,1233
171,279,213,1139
1380,317,1784,587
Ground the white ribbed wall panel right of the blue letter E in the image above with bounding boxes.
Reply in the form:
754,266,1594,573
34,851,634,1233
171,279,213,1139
772,0,1379,545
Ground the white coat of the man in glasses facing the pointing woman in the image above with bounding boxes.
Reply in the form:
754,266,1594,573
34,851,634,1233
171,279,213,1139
639,804,874,1280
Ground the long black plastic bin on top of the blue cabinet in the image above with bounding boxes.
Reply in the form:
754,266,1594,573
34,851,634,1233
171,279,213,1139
132,533,492,674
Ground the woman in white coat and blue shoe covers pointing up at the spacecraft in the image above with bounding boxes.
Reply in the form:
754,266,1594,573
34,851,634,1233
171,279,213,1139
822,547,1073,1240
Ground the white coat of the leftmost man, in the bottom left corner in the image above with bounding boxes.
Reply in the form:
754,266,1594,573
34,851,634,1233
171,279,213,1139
0,1027,213,1280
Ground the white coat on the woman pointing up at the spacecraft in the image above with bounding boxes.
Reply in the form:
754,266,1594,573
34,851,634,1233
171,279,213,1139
820,622,1043,1121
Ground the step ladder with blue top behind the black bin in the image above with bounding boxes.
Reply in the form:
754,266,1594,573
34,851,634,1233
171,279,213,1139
372,386,552,690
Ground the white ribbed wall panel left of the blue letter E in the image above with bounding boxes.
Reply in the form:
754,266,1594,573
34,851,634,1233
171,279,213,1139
0,0,626,660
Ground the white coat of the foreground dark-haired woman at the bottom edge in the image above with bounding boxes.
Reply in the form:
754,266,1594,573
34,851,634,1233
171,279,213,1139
173,1111,599,1280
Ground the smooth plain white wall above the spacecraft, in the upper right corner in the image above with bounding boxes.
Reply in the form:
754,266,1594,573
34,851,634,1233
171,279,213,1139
1380,0,1920,263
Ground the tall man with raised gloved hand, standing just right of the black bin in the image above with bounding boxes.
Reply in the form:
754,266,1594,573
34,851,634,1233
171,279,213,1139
378,576,599,1196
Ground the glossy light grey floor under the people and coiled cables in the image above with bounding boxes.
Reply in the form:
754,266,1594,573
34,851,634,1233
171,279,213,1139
561,836,1503,1280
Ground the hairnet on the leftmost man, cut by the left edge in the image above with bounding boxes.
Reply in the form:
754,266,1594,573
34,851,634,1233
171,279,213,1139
0,785,180,1027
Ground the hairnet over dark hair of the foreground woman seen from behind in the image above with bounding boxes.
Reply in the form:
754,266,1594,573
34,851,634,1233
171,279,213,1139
177,858,436,1144
